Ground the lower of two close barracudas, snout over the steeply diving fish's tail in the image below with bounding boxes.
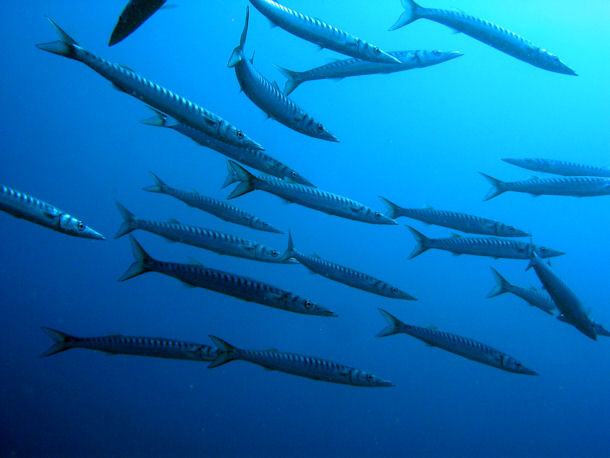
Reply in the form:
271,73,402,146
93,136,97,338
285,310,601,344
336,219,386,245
407,226,565,259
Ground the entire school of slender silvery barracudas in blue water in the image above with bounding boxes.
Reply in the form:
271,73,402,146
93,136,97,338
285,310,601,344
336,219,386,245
0,0,610,387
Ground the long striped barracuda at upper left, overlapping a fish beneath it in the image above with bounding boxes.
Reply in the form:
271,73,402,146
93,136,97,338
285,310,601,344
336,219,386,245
36,19,263,149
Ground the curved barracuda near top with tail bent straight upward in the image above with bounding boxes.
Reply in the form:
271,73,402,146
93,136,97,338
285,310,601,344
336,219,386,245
228,11,339,142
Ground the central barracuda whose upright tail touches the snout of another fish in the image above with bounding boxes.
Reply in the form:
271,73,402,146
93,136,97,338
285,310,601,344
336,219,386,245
282,234,417,301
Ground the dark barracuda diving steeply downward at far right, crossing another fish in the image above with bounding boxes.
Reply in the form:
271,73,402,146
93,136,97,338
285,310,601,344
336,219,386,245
528,253,597,340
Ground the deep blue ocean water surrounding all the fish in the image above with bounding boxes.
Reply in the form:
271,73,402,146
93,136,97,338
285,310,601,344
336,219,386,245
0,0,610,457
